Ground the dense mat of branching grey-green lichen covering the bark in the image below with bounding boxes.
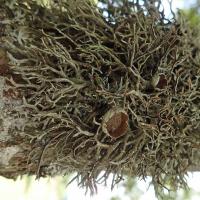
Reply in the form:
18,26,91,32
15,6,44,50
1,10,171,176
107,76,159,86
0,0,200,197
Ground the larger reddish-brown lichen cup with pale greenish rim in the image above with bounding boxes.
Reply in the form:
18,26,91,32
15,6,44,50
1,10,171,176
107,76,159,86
102,108,128,138
